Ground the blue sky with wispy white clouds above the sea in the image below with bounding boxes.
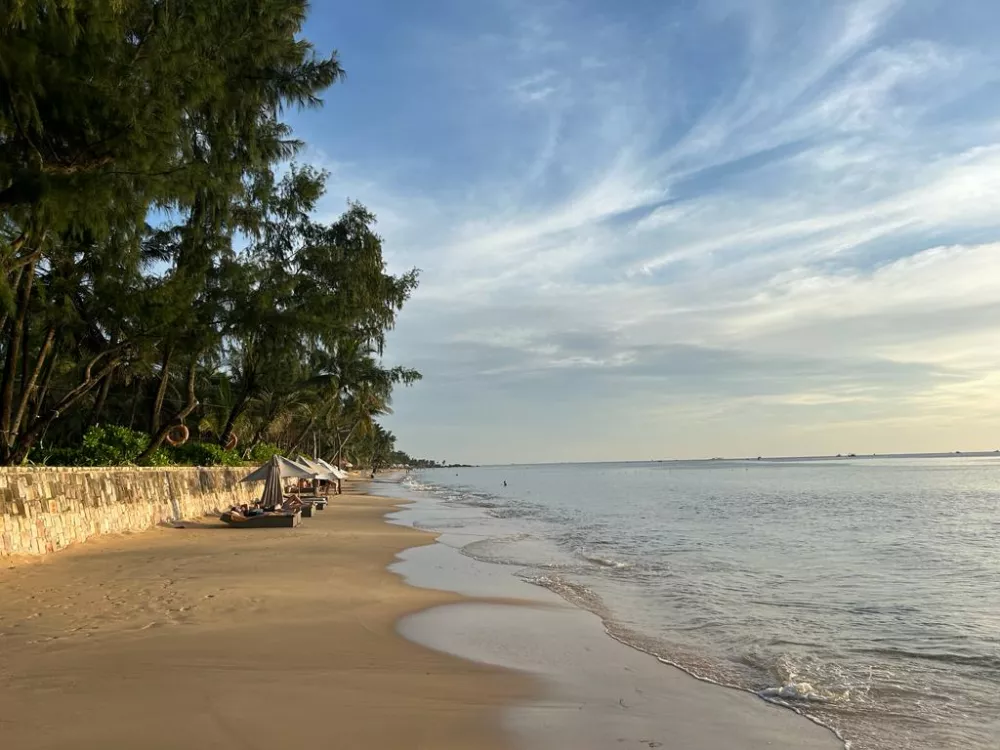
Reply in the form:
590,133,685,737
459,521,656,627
290,0,1000,463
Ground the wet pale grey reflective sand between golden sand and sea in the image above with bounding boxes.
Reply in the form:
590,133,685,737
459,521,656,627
382,476,847,750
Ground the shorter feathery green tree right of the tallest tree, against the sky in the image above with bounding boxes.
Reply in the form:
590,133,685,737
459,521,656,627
219,168,419,452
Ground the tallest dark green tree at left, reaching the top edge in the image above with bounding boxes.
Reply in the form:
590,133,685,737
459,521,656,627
0,0,342,463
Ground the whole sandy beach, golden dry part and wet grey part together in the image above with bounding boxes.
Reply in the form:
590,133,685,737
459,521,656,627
0,484,840,750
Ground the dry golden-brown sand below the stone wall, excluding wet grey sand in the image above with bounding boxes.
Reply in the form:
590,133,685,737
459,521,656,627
0,494,535,750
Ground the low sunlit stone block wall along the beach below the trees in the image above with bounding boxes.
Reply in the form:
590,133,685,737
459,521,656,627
0,467,261,557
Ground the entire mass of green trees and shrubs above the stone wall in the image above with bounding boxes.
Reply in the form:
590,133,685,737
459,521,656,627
0,0,420,466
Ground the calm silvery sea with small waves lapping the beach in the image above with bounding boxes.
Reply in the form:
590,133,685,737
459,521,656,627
404,458,1000,750
